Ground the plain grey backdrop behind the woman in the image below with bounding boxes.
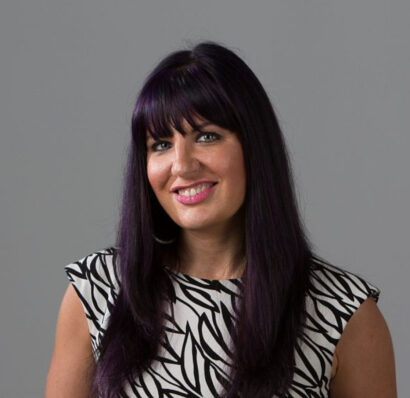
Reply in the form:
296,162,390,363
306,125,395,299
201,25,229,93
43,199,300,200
0,0,410,398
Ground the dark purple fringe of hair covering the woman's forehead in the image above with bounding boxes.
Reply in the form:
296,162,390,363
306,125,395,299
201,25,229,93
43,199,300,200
136,66,238,144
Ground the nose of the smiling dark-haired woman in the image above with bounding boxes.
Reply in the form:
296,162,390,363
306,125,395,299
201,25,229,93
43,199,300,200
171,134,200,177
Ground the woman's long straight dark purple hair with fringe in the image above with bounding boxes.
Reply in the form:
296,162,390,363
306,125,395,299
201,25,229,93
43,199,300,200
93,41,313,398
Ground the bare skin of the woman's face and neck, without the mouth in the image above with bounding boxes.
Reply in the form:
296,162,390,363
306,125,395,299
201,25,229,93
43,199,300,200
147,118,246,279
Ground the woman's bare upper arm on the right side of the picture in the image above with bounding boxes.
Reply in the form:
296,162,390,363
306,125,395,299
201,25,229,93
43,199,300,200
330,297,397,398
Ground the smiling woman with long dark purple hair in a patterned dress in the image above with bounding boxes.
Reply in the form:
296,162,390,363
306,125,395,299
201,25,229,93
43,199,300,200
46,42,396,398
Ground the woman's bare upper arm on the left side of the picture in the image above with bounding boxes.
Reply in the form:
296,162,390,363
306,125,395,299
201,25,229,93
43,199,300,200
45,284,95,398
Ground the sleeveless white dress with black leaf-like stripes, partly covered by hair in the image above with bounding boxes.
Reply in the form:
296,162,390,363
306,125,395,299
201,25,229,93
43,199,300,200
64,247,380,398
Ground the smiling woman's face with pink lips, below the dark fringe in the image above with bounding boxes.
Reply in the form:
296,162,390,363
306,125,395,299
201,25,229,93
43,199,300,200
147,115,246,231
